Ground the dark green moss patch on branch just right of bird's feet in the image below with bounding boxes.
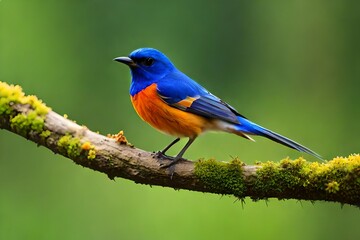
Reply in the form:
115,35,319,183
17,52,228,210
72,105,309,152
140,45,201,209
195,159,246,198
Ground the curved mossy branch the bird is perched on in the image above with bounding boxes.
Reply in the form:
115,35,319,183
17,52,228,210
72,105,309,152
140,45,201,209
0,82,360,206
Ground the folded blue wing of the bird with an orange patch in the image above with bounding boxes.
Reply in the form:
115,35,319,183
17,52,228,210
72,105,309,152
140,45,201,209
157,71,243,124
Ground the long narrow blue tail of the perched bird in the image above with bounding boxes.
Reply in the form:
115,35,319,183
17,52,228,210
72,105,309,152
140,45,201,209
235,116,322,159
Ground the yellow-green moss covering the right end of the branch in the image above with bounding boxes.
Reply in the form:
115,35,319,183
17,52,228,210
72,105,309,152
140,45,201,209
253,155,360,202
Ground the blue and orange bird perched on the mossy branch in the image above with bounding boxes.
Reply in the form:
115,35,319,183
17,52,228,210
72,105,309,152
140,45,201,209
113,48,322,167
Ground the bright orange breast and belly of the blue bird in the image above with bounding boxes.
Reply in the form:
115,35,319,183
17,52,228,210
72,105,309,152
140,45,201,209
131,83,208,137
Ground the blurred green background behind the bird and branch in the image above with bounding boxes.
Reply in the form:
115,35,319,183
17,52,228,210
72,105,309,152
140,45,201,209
0,0,360,240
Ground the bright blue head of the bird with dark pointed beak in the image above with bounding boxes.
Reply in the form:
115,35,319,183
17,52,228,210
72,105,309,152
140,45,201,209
114,48,175,82
